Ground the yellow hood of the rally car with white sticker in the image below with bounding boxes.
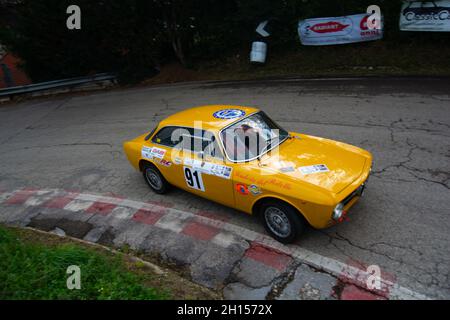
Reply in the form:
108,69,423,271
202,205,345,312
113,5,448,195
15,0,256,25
261,134,371,193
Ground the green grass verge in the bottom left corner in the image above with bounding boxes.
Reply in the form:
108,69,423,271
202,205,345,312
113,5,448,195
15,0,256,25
0,226,218,300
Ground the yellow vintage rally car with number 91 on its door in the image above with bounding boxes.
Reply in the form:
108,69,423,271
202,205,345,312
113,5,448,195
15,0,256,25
124,105,372,243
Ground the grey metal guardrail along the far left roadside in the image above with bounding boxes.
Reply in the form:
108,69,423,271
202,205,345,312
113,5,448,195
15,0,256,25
0,73,117,98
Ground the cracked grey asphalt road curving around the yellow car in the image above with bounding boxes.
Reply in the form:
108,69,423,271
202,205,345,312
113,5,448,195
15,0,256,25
0,79,450,299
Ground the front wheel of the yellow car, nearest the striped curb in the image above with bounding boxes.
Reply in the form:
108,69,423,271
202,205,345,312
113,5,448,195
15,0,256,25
259,200,306,244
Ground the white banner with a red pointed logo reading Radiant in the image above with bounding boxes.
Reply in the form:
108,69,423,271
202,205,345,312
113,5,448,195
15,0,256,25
298,13,383,46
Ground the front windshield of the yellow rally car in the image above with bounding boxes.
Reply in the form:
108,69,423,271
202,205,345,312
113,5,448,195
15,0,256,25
220,112,289,161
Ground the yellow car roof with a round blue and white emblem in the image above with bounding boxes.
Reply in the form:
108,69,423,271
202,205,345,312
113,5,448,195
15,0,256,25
160,105,260,132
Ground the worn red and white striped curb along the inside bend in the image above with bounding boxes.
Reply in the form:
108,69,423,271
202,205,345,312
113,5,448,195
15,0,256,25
0,188,428,300
